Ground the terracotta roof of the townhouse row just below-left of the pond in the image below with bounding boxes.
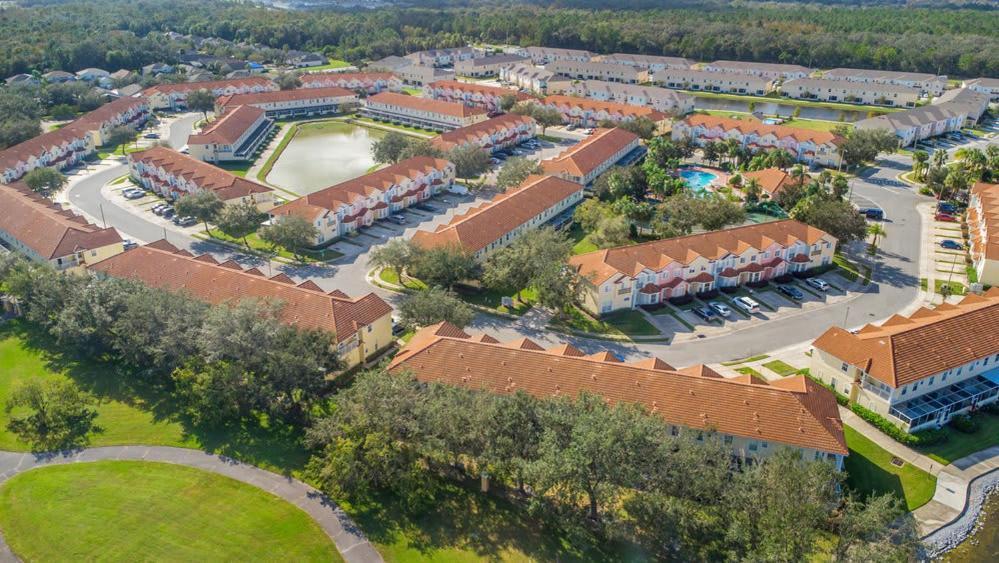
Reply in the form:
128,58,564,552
128,147,272,201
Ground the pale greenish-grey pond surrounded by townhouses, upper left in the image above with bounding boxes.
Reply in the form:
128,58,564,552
267,122,385,195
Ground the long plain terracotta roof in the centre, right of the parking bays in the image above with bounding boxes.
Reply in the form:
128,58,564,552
412,176,583,253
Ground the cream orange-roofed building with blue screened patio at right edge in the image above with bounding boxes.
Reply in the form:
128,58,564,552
810,288,999,432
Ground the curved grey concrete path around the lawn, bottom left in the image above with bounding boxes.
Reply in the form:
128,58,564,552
0,446,382,563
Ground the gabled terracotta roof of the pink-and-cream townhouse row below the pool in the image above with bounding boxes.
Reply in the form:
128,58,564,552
569,219,836,284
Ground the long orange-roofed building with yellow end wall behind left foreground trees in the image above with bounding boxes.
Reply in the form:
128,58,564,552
90,240,395,369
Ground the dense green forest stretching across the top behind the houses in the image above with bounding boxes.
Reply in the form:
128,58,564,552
0,0,999,77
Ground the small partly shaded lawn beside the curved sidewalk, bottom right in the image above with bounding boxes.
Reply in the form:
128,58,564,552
843,425,937,510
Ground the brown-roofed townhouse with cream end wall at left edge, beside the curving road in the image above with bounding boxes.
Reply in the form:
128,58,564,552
0,182,125,271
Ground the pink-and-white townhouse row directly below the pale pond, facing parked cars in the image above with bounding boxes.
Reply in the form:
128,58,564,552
270,156,455,246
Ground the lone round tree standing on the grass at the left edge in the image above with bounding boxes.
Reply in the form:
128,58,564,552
6,379,97,450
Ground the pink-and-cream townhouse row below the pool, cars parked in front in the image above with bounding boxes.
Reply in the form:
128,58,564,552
569,220,837,315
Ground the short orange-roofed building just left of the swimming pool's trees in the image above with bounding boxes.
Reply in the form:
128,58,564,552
541,127,645,186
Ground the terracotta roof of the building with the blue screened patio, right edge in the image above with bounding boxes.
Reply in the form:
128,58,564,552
812,288,999,387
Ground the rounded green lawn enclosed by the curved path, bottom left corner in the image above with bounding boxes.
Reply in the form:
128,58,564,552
0,461,342,561
